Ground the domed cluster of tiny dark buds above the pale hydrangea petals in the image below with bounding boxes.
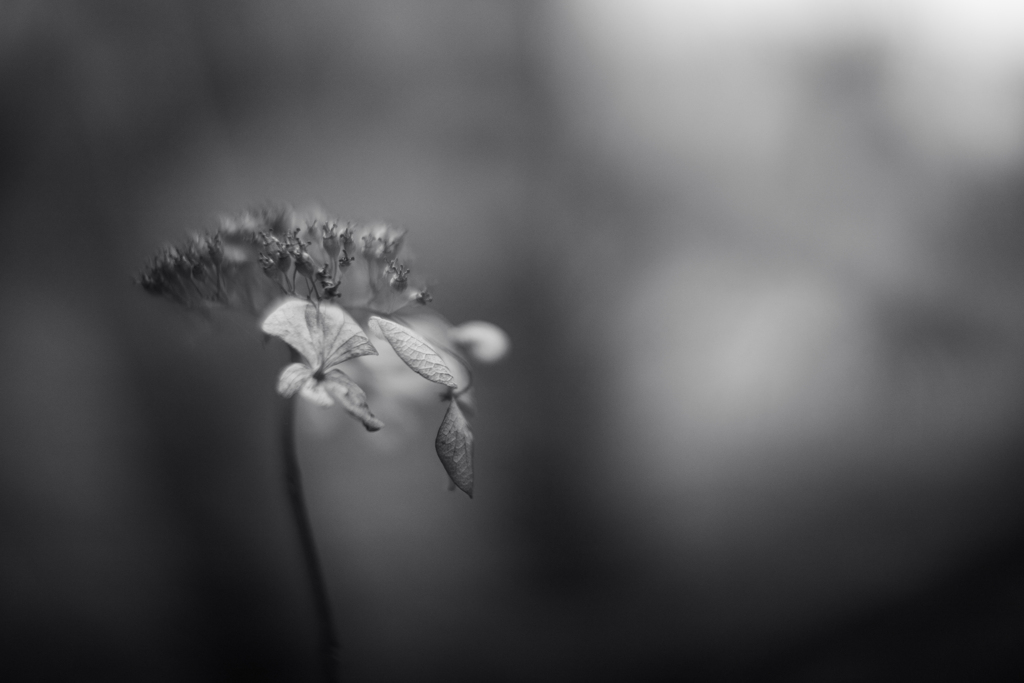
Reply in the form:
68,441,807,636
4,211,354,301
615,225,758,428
138,208,431,314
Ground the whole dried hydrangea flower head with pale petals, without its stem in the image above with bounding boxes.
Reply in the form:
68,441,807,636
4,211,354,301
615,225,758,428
138,202,509,497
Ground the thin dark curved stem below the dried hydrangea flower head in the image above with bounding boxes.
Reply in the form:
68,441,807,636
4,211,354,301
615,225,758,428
282,398,339,683
